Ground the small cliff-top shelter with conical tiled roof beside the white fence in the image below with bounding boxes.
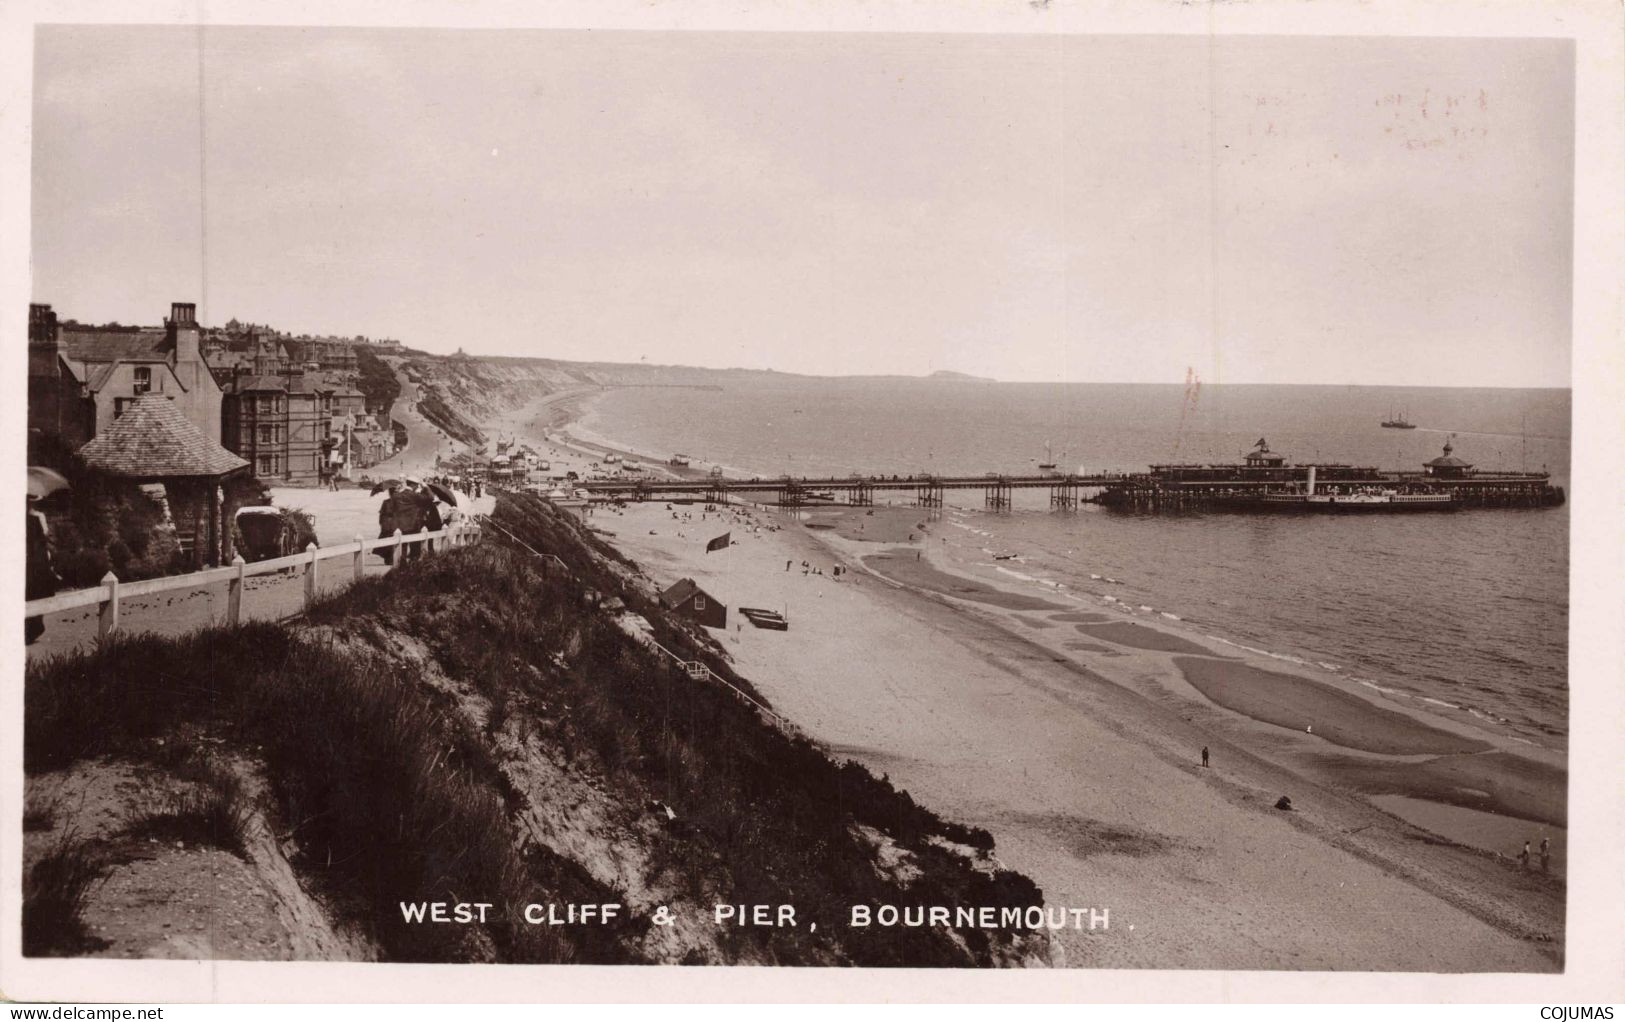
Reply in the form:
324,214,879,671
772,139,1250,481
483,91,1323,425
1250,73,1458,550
78,393,249,569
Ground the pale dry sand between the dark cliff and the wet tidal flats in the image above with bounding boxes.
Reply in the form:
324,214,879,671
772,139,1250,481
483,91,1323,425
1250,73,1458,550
562,504,1562,972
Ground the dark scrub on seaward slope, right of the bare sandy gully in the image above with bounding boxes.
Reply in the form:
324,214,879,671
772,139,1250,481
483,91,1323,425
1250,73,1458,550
317,494,1043,965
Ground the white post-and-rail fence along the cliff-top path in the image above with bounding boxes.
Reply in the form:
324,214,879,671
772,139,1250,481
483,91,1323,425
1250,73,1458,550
23,525,479,637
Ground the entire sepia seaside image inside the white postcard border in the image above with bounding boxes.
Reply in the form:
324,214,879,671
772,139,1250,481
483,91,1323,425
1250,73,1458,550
5,3,1620,996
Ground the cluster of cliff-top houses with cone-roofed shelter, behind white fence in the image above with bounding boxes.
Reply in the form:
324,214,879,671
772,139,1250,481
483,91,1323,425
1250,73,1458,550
28,302,425,581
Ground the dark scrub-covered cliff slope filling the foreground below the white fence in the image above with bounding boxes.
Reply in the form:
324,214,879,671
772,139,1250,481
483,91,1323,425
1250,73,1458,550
24,497,1048,965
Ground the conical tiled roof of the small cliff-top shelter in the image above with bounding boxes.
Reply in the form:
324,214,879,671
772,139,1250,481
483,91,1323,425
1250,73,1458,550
80,393,249,479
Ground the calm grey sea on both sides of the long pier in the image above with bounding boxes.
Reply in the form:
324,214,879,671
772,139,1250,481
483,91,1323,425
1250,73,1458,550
580,375,1571,749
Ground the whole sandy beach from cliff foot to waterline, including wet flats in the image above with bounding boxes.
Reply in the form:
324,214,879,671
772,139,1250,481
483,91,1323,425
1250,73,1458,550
505,395,1567,972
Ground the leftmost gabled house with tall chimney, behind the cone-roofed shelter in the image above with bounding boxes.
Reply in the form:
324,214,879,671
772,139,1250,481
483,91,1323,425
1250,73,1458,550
28,302,221,448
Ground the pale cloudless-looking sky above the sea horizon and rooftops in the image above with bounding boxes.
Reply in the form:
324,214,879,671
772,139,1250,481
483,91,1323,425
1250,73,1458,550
31,26,1575,387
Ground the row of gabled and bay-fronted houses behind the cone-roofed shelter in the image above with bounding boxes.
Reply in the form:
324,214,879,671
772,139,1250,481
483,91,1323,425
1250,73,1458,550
28,302,393,484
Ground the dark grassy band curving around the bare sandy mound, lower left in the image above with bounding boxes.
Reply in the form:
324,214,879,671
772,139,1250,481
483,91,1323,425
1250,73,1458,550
23,622,631,962
